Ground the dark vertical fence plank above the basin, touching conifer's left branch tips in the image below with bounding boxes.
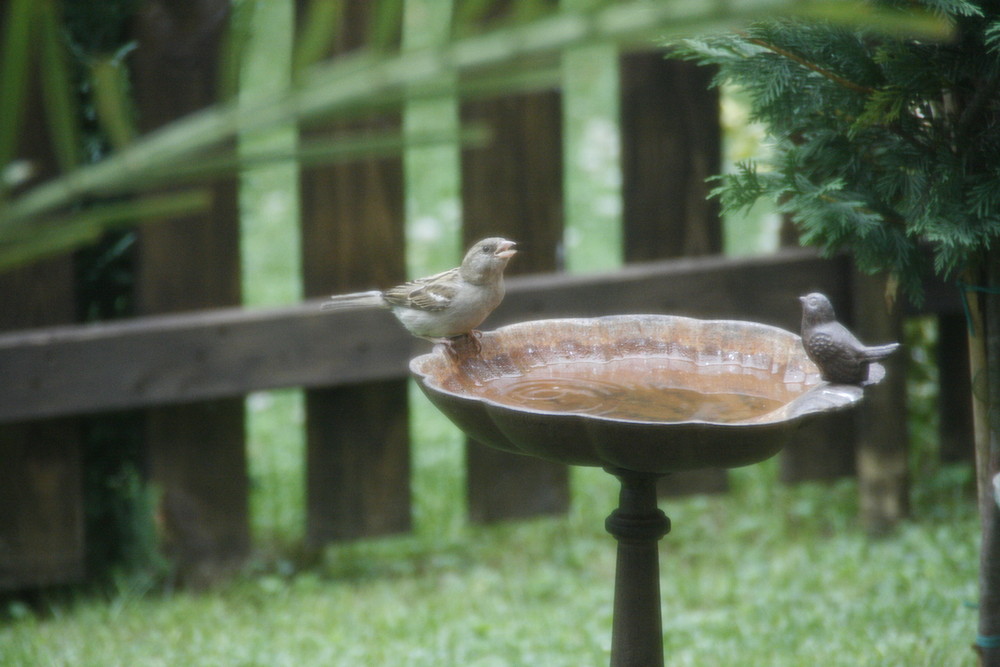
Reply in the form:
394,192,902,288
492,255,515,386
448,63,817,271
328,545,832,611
619,51,728,495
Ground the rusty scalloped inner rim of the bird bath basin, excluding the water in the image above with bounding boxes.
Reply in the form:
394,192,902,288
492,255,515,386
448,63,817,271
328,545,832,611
410,315,863,428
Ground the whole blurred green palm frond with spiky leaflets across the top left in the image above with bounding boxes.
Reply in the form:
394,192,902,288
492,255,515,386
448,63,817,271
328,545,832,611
0,0,940,270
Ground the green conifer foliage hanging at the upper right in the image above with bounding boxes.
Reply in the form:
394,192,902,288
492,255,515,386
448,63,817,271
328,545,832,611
674,0,1000,299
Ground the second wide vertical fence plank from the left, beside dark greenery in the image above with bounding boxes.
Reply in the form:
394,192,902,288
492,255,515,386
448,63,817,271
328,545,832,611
134,0,250,585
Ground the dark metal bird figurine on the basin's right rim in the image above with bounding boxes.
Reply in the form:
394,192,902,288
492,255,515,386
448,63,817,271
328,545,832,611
799,292,899,385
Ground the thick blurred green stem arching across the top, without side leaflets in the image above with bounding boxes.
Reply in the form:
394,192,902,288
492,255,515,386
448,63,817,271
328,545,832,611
0,0,947,266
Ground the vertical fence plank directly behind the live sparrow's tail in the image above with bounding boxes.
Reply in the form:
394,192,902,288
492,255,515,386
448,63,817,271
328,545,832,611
298,0,412,547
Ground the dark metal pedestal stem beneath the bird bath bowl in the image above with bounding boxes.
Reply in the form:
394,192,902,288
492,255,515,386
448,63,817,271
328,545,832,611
605,470,670,667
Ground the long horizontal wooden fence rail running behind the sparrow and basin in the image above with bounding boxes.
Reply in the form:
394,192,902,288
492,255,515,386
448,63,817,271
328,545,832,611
0,250,849,422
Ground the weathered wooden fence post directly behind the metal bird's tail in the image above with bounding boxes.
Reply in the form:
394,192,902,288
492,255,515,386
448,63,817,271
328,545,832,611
854,273,909,534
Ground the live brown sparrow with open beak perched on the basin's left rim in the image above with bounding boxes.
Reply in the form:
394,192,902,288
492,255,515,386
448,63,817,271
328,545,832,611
320,237,517,348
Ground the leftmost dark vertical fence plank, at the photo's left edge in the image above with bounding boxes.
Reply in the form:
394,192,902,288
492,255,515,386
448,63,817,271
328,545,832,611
0,1,84,590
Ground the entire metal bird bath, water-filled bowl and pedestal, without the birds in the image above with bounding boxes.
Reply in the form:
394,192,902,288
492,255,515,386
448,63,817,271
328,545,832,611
410,315,876,667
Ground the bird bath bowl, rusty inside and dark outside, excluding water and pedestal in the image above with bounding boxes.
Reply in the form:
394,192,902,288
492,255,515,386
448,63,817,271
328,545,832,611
410,315,863,474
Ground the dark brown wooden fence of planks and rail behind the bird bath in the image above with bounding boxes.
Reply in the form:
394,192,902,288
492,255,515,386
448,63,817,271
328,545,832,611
0,0,968,589
